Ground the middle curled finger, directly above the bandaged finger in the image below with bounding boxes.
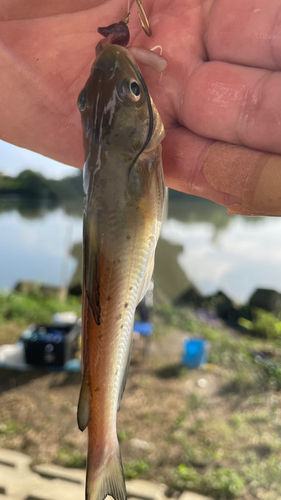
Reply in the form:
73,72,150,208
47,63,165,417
177,62,281,153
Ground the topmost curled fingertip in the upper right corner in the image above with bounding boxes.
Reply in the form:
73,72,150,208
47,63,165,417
205,0,281,70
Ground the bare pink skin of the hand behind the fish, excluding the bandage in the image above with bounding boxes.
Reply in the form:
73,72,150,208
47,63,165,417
0,0,281,210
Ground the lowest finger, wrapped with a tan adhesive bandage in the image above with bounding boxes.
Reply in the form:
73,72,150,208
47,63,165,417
163,127,281,216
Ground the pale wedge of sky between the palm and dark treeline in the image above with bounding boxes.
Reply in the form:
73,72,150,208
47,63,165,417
0,140,78,179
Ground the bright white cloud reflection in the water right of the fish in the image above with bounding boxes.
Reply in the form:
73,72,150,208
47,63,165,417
161,216,281,304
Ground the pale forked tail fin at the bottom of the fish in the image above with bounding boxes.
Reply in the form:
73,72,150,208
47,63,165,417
86,443,127,500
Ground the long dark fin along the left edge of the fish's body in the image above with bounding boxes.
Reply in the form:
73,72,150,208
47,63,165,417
84,210,101,325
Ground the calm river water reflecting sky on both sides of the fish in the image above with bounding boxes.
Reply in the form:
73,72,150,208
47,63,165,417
0,195,281,303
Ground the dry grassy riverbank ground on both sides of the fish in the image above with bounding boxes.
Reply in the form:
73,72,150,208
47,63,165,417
0,291,281,500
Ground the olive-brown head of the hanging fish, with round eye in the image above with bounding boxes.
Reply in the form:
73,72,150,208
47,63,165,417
78,45,153,164
